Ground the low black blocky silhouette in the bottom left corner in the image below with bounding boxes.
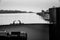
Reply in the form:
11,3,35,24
0,32,27,40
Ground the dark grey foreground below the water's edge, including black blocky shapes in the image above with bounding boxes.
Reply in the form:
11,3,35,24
0,24,49,40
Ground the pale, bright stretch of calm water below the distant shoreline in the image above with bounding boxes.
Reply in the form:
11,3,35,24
0,13,49,24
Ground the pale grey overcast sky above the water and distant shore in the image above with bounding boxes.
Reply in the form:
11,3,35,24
0,0,59,12
